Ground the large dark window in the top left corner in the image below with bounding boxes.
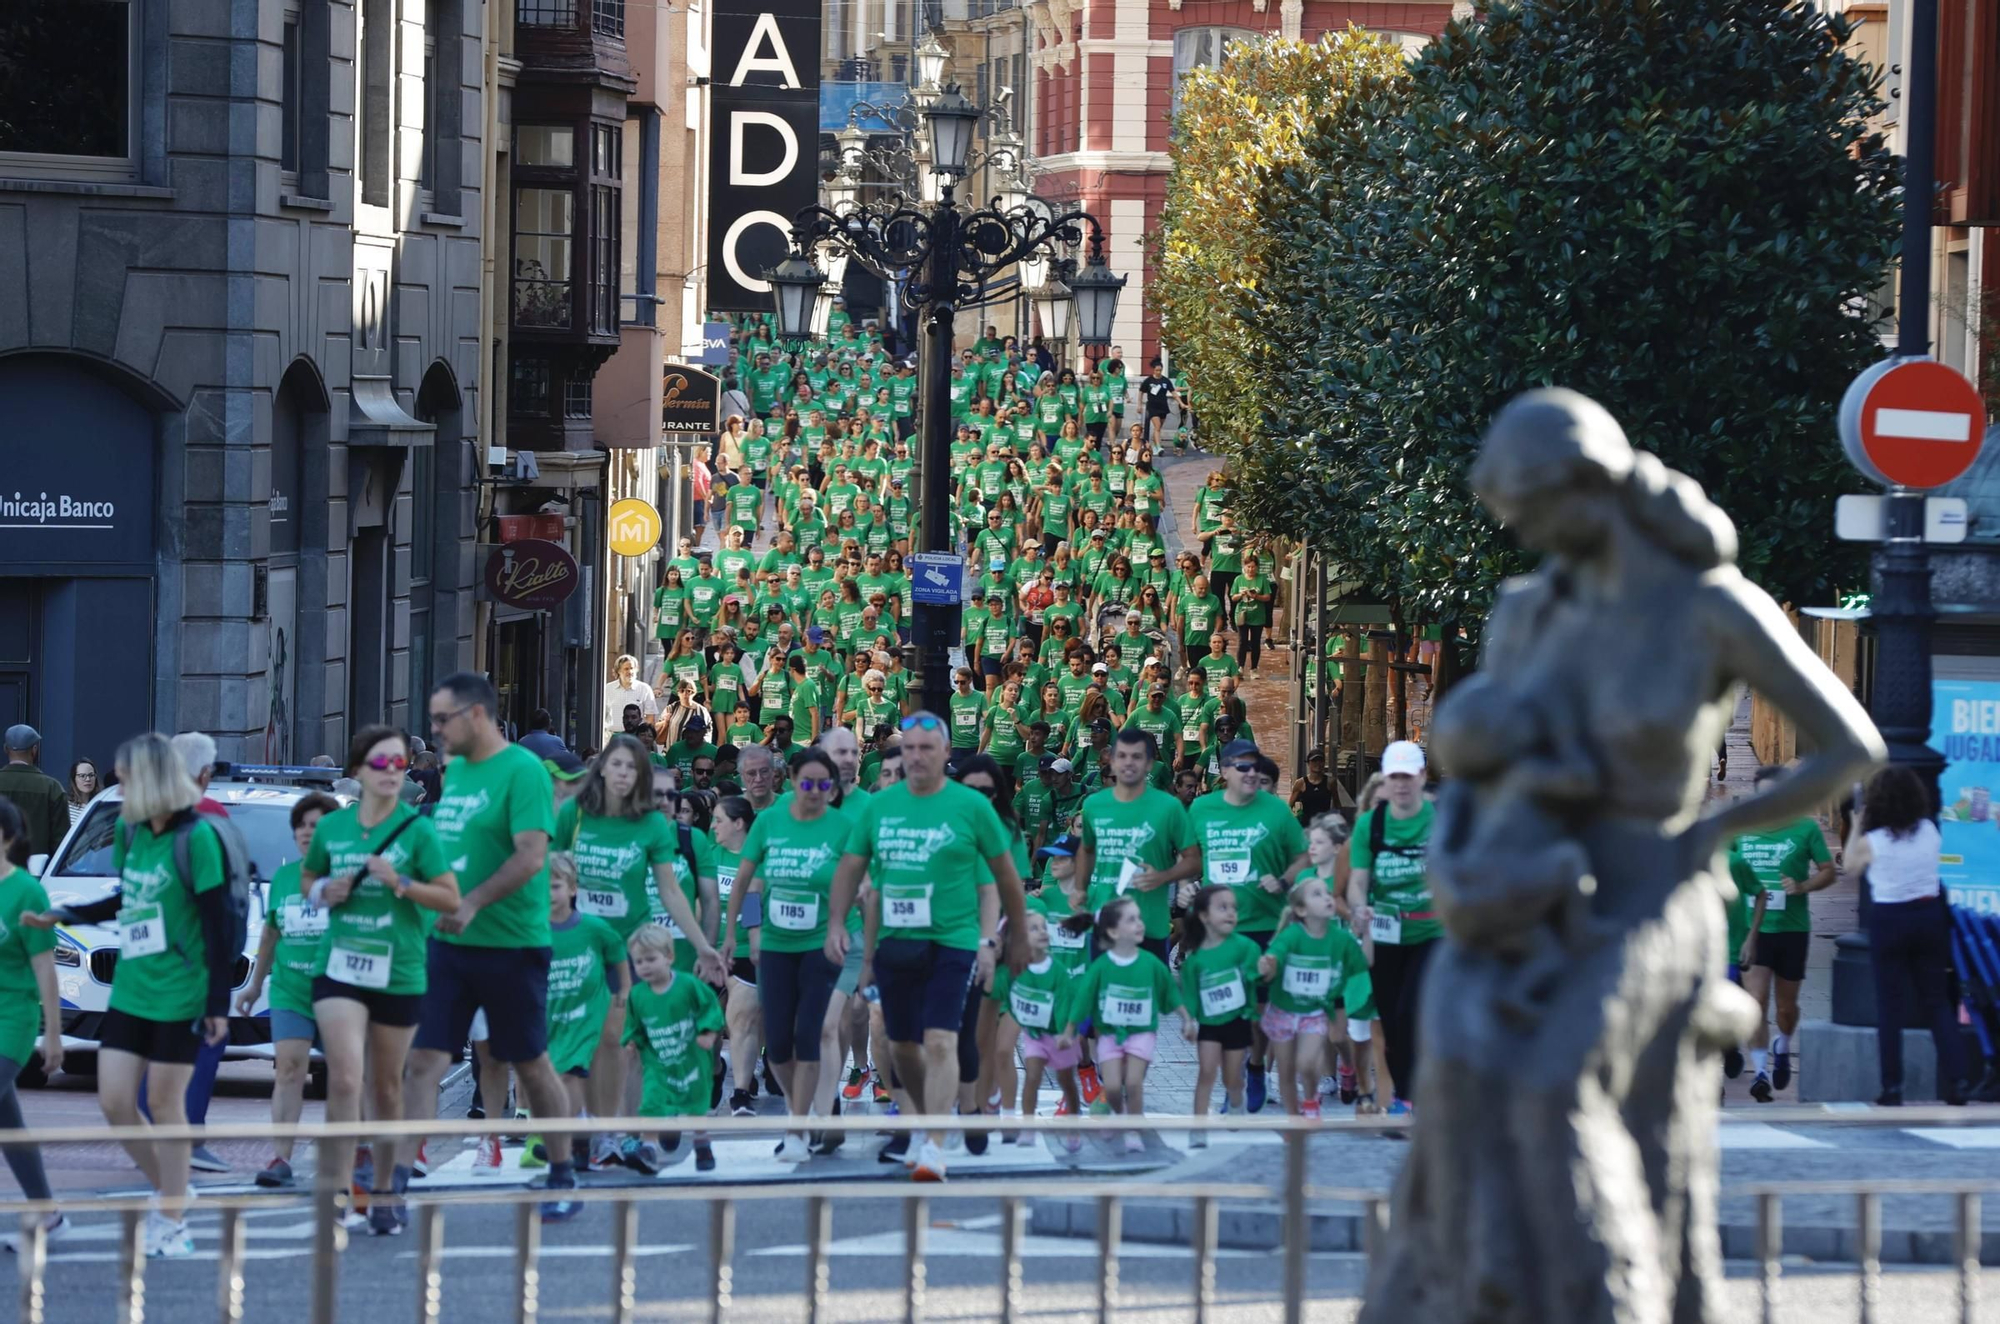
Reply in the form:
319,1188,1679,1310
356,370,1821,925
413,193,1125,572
0,0,138,178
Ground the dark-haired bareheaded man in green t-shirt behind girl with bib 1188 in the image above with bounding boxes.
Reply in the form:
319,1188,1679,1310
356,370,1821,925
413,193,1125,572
1076,730,1202,962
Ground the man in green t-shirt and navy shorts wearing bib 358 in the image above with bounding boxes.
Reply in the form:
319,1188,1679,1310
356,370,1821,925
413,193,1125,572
826,712,1032,1182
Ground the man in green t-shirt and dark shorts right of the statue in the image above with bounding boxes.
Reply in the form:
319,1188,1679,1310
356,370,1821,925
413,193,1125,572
1730,766,1836,1104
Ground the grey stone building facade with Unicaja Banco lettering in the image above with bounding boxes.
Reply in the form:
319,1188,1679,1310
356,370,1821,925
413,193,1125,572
0,0,490,776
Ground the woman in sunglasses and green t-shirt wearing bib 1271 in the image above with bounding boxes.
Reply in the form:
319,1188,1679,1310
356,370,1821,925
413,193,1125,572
298,726,458,1236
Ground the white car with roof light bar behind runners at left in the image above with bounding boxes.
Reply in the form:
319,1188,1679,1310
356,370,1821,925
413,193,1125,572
24,764,340,1084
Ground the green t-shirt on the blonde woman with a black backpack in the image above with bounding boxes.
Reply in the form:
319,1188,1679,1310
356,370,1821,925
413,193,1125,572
109,820,227,1022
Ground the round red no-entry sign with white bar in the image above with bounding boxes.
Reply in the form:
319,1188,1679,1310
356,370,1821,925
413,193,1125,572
1840,358,1986,488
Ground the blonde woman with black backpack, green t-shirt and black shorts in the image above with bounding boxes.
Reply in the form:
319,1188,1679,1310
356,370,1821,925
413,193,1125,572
20,732,240,1258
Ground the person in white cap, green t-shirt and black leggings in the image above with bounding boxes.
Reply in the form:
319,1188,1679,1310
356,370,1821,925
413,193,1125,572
1348,740,1444,1114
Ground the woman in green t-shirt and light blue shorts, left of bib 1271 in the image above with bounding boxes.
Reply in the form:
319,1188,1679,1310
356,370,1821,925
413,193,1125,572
236,790,340,1190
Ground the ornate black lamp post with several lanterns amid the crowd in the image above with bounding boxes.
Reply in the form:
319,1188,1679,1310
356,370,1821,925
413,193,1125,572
768,86,1126,712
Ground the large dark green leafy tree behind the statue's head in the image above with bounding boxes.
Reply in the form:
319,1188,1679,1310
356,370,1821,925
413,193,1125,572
1234,0,1900,652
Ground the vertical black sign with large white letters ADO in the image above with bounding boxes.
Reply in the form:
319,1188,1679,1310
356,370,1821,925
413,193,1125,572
708,0,820,312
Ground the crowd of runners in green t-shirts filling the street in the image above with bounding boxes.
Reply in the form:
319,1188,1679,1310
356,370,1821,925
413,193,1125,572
0,308,1904,1256
